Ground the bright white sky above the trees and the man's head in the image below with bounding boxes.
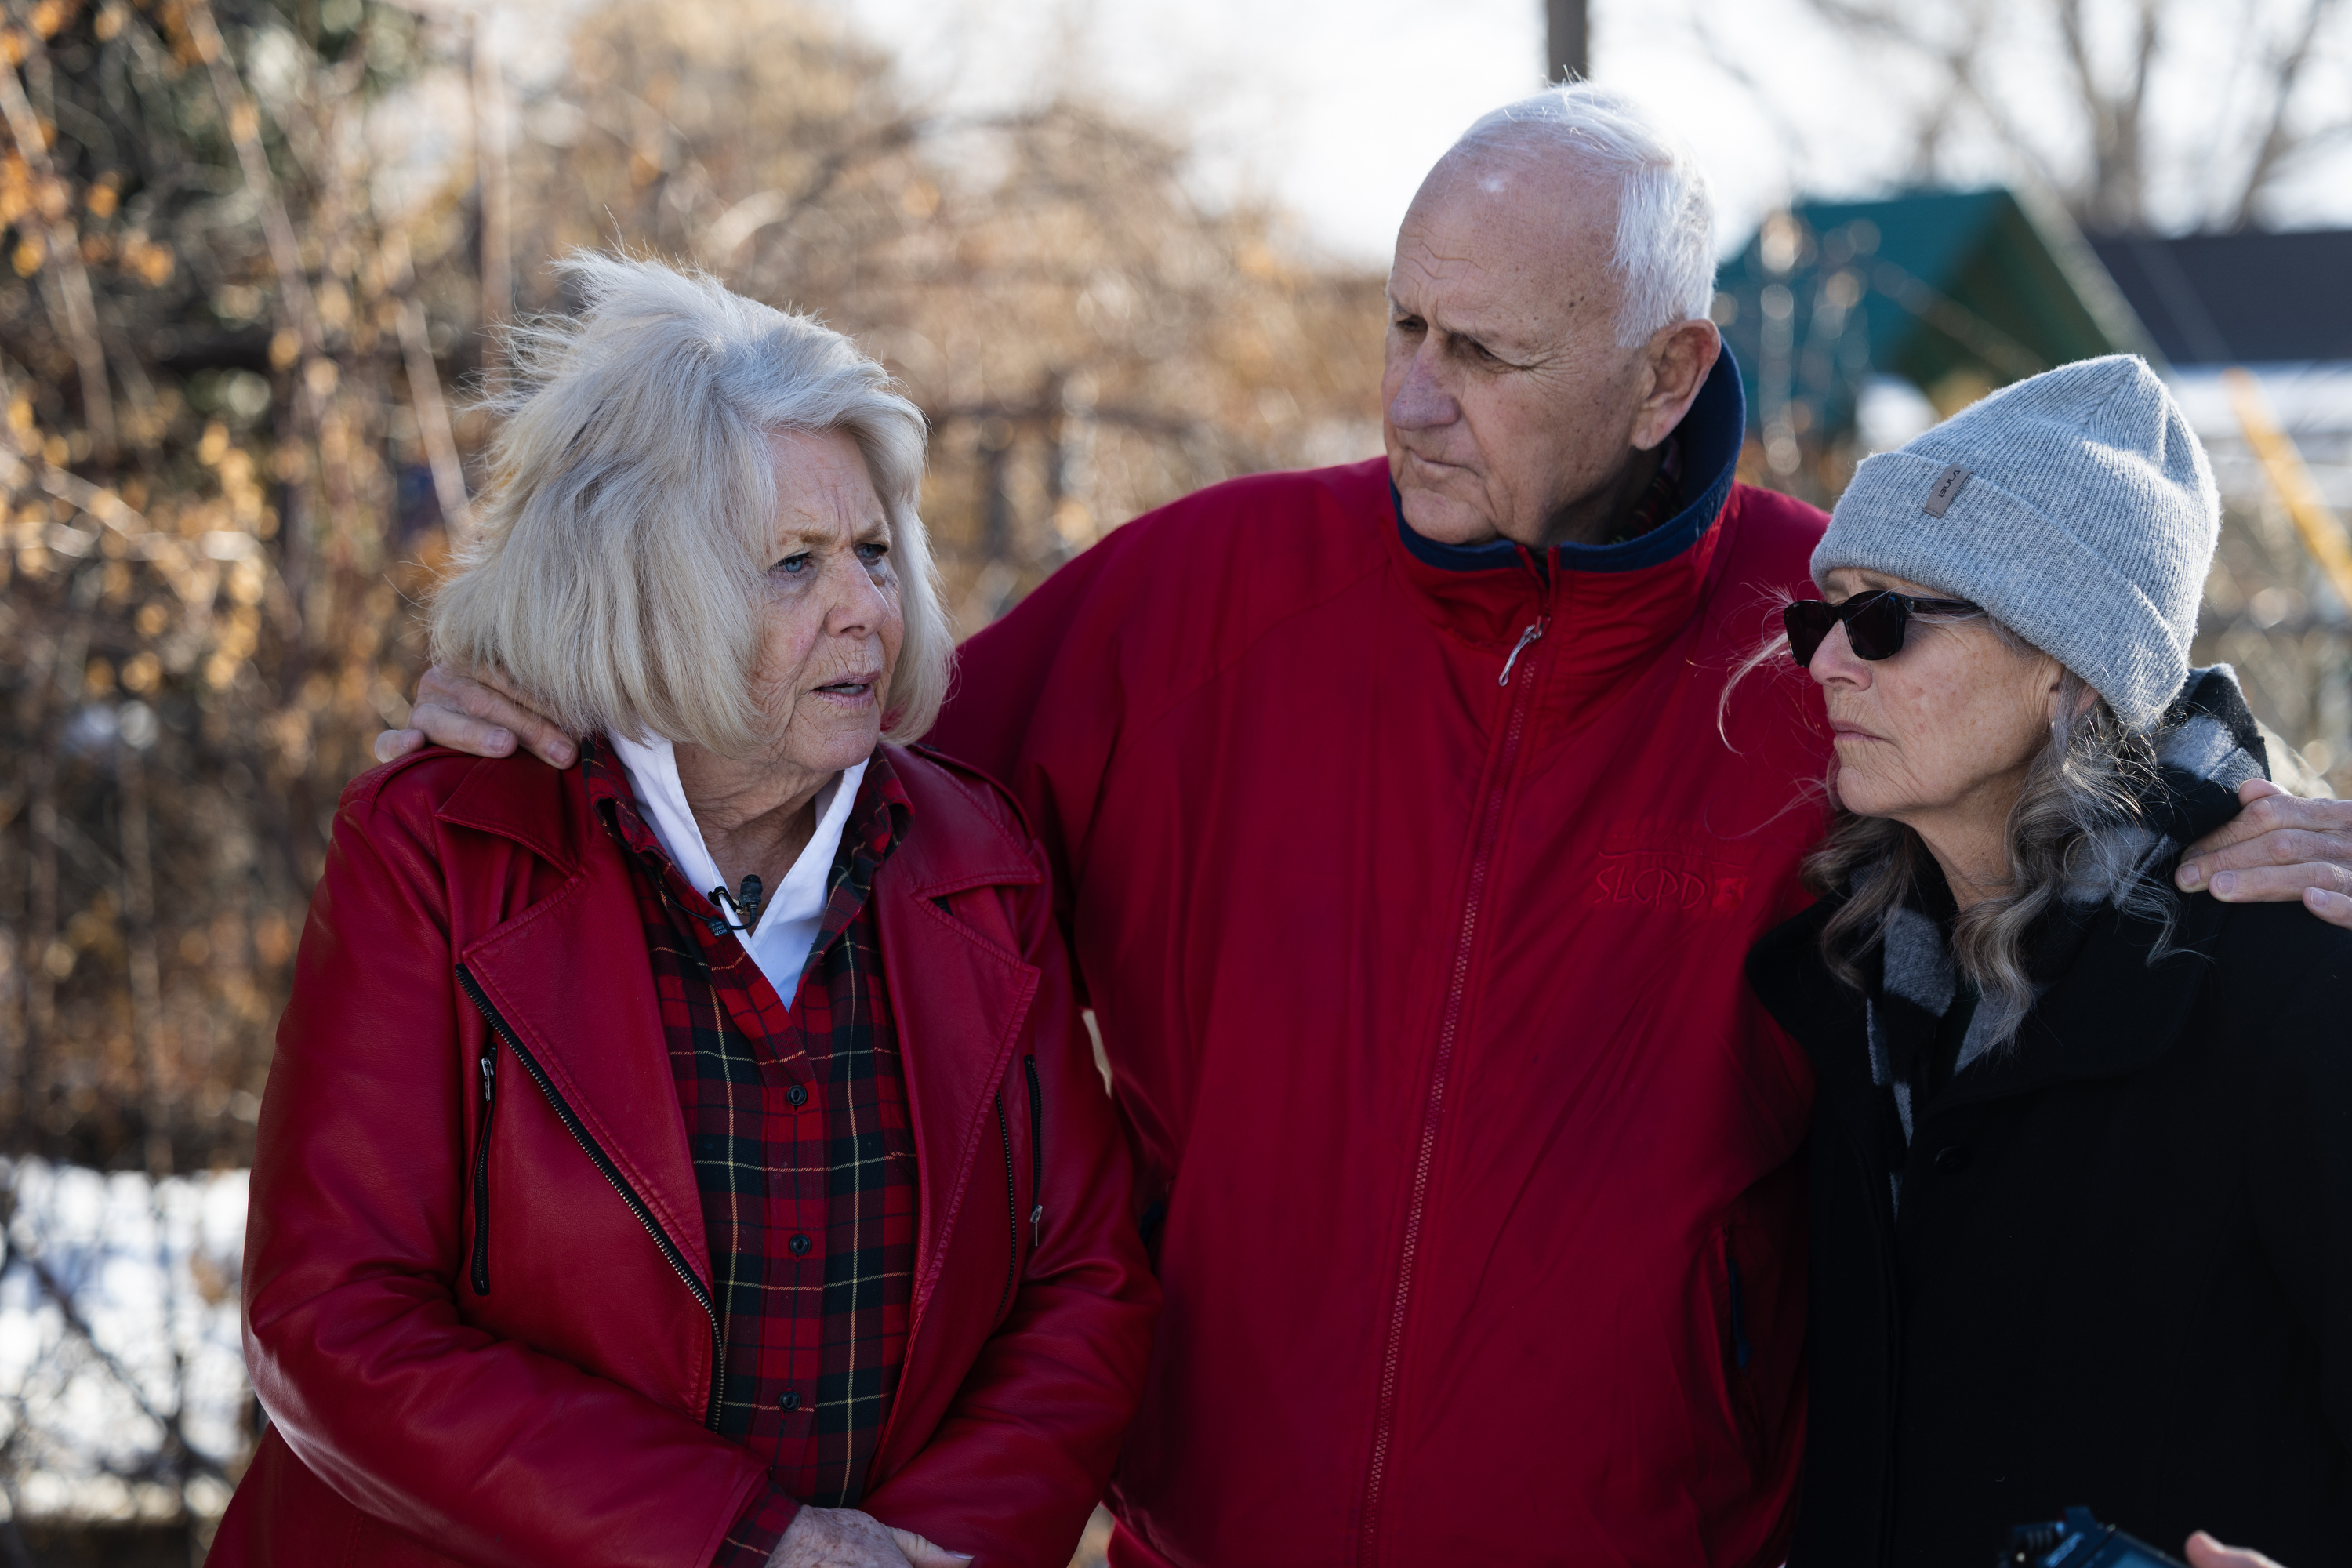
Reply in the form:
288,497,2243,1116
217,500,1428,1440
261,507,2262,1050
821,0,2352,263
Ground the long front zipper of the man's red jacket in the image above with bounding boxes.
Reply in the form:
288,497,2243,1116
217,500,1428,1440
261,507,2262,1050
1357,548,1557,1568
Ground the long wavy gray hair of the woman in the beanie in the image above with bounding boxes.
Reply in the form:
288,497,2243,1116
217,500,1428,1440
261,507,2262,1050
1726,614,2178,1051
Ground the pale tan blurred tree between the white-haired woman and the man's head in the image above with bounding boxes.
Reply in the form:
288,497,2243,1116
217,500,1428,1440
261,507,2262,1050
510,0,1381,630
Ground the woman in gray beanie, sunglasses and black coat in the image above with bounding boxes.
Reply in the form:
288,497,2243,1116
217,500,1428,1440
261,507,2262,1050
1748,358,2352,1568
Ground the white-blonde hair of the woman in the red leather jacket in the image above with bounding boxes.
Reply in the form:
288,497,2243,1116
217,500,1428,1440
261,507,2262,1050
430,252,953,757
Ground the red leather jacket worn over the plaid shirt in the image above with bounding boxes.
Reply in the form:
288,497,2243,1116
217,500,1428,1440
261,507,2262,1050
212,750,1157,1568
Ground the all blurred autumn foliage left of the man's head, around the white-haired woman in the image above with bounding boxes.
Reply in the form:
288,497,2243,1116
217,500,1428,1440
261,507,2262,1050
0,0,1381,1189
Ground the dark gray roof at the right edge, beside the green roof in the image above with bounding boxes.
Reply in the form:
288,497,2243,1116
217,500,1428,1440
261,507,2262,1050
2091,228,2352,365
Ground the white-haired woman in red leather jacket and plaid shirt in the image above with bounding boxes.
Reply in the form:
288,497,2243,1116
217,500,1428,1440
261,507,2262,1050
212,256,1157,1568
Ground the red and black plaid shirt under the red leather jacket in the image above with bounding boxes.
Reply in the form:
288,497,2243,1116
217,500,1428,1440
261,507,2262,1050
581,743,915,1568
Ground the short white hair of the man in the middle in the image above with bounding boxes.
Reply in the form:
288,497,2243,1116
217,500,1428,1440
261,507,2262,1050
1449,82,1715,348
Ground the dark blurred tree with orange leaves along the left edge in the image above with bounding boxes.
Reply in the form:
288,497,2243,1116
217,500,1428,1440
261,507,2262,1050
0,0,477,1173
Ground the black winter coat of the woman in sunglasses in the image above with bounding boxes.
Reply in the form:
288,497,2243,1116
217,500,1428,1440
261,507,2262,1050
1748,884,2352,1568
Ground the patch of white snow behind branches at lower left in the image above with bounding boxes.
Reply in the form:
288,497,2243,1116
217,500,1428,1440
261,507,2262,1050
0,1159,252,1519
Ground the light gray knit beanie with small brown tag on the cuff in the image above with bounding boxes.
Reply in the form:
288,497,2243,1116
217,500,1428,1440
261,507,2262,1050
1813,355,2220,729
